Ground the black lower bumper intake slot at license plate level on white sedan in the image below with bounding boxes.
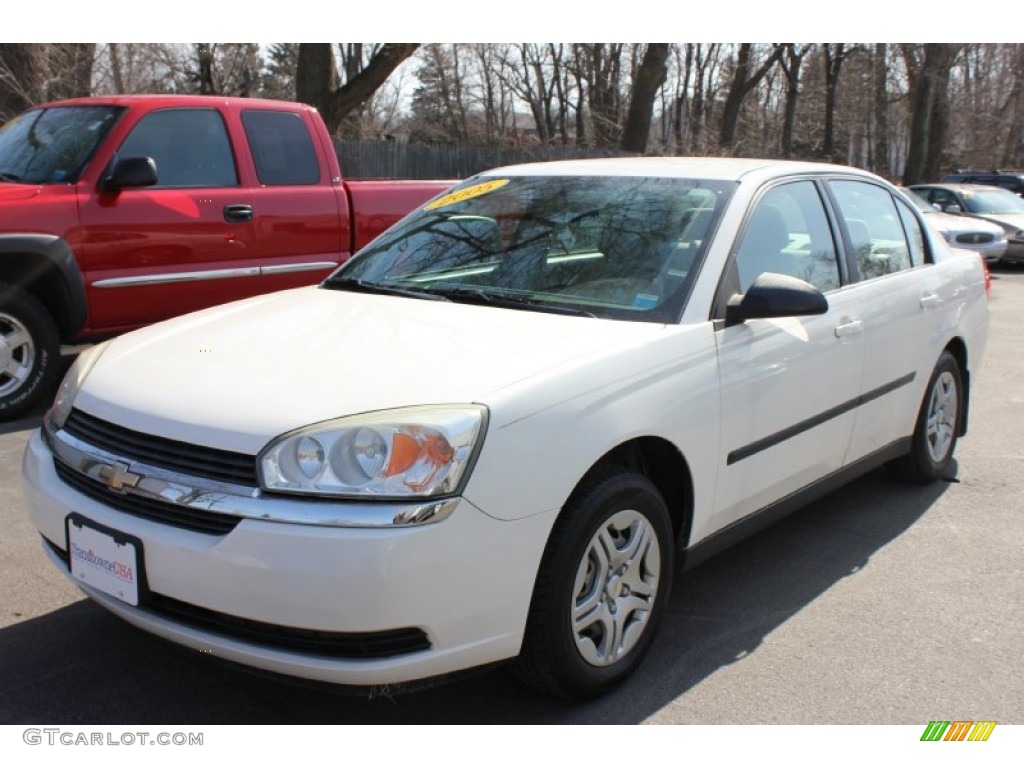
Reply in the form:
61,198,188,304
43,537,430,658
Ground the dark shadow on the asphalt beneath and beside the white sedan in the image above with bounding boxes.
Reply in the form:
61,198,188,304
0,472,947,724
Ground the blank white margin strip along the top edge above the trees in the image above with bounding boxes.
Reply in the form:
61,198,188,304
12,0,1020,43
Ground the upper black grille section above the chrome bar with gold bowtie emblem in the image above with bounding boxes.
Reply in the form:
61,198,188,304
63,409,259,487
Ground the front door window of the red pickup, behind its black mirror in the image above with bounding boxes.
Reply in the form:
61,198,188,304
118,110,239,188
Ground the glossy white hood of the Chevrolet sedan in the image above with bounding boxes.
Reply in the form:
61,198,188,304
75,288,664,454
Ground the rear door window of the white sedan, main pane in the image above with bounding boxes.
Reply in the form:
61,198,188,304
829,180,912,280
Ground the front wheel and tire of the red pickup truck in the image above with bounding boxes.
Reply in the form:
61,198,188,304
0,283,60,421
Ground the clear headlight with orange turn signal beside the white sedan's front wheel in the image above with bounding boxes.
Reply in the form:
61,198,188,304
258,406,486,499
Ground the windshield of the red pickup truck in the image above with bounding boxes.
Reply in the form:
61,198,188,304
0,106,122,184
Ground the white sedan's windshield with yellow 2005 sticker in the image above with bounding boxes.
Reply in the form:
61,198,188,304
324,175,735,323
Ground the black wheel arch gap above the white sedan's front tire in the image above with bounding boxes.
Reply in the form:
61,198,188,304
562,435,693,546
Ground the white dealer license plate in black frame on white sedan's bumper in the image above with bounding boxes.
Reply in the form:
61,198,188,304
68,514,141,605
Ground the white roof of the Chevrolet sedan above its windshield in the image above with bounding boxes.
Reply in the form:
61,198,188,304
482,158,880,181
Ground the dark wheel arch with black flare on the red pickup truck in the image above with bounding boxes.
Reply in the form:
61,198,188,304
0,234,87,342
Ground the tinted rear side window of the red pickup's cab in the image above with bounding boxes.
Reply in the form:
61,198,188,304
242,110,319,186
